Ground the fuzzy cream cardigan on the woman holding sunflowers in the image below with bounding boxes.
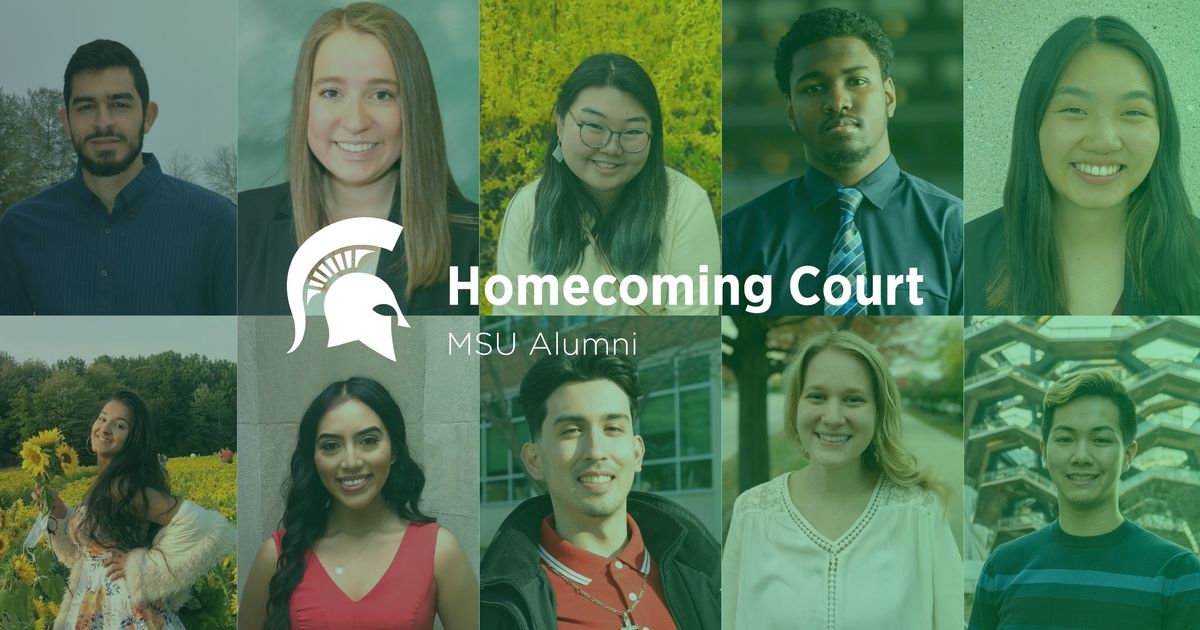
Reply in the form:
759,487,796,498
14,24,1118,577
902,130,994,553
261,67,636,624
49,500,238,630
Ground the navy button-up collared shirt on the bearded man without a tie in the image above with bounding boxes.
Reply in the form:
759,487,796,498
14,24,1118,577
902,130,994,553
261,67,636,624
0,154,238,314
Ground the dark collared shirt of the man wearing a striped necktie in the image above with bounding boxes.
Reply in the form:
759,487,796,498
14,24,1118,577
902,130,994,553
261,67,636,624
721,156,962,314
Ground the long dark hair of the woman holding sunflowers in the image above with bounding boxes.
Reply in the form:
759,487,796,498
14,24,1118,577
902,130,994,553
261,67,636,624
82,390,170,550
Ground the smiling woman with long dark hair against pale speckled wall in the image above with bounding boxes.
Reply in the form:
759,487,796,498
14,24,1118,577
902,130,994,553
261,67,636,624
966,16,1200,316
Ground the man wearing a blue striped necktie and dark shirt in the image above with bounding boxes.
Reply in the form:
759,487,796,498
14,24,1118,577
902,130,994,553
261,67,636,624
722,8,962,316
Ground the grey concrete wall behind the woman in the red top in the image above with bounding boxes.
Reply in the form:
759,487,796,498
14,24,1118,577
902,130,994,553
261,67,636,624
238,317,479,590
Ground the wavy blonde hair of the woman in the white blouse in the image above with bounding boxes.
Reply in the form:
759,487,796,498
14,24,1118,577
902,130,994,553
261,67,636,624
784,330,944,498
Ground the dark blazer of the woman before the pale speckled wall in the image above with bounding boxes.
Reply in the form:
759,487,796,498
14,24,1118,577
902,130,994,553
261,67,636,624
966,209,1154,316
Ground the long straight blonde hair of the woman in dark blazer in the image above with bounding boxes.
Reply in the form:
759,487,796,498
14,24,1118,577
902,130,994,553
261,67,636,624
288,2,472,294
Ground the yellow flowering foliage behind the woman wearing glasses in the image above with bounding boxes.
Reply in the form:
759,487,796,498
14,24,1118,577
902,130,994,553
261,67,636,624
479,0,721,278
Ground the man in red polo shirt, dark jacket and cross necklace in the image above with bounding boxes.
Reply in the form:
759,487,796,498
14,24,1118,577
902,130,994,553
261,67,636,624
480,343,721,630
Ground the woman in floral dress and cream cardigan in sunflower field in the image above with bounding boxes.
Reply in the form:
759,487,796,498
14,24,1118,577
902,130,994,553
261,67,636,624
34,391,235,630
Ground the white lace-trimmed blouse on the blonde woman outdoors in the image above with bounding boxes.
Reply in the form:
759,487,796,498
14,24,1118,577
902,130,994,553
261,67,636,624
721,473,962,630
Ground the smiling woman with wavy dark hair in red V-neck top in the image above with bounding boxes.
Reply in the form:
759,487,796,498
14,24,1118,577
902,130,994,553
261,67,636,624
238,377,479,630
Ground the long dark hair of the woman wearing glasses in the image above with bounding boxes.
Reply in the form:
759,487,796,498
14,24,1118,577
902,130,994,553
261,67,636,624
529,53,668,275
